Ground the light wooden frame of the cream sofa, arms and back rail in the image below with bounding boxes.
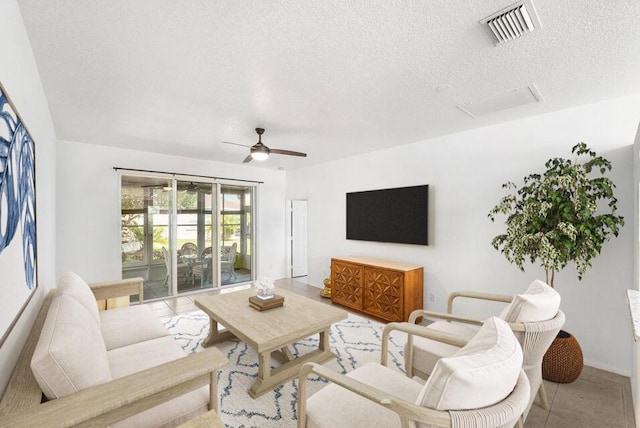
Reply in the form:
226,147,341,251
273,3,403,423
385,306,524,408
0,278,228,427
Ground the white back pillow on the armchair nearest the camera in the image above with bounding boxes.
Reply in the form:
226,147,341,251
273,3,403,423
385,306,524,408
416,317,522,410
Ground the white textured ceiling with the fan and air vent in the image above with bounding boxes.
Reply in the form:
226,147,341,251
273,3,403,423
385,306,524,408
18,0,640,169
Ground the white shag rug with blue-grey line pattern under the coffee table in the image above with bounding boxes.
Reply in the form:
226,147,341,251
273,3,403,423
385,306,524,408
162,311,406,428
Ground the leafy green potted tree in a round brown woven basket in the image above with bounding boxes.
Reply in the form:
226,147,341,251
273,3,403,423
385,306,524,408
489,143,624,382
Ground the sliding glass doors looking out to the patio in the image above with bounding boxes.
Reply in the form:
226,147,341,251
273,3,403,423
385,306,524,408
120,174,255,300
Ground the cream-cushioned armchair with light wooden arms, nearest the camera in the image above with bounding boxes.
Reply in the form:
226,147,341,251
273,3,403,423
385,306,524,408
298,317,529,428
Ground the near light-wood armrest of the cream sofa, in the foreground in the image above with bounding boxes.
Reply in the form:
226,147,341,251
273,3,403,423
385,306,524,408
0,348,228,427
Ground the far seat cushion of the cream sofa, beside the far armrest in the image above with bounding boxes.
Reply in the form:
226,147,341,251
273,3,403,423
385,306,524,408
99,305,169,350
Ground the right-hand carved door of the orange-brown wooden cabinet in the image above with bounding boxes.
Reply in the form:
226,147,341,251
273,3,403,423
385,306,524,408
362,266,404,321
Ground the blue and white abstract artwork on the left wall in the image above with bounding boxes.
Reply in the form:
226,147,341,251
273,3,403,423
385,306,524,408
0,84,37,343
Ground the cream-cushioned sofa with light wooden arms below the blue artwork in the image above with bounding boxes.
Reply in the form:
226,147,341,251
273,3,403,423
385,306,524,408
0,273,227,427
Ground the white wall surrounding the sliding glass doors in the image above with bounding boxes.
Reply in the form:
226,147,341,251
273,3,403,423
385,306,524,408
56,141,286,282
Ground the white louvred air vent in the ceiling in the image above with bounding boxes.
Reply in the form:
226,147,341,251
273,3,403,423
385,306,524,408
480,0,540,44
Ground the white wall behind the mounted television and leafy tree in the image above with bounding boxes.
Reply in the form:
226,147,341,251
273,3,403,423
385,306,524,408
287,96,640,375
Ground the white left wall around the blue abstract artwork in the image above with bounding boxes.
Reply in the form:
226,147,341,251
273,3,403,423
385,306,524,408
0,0,56,395
